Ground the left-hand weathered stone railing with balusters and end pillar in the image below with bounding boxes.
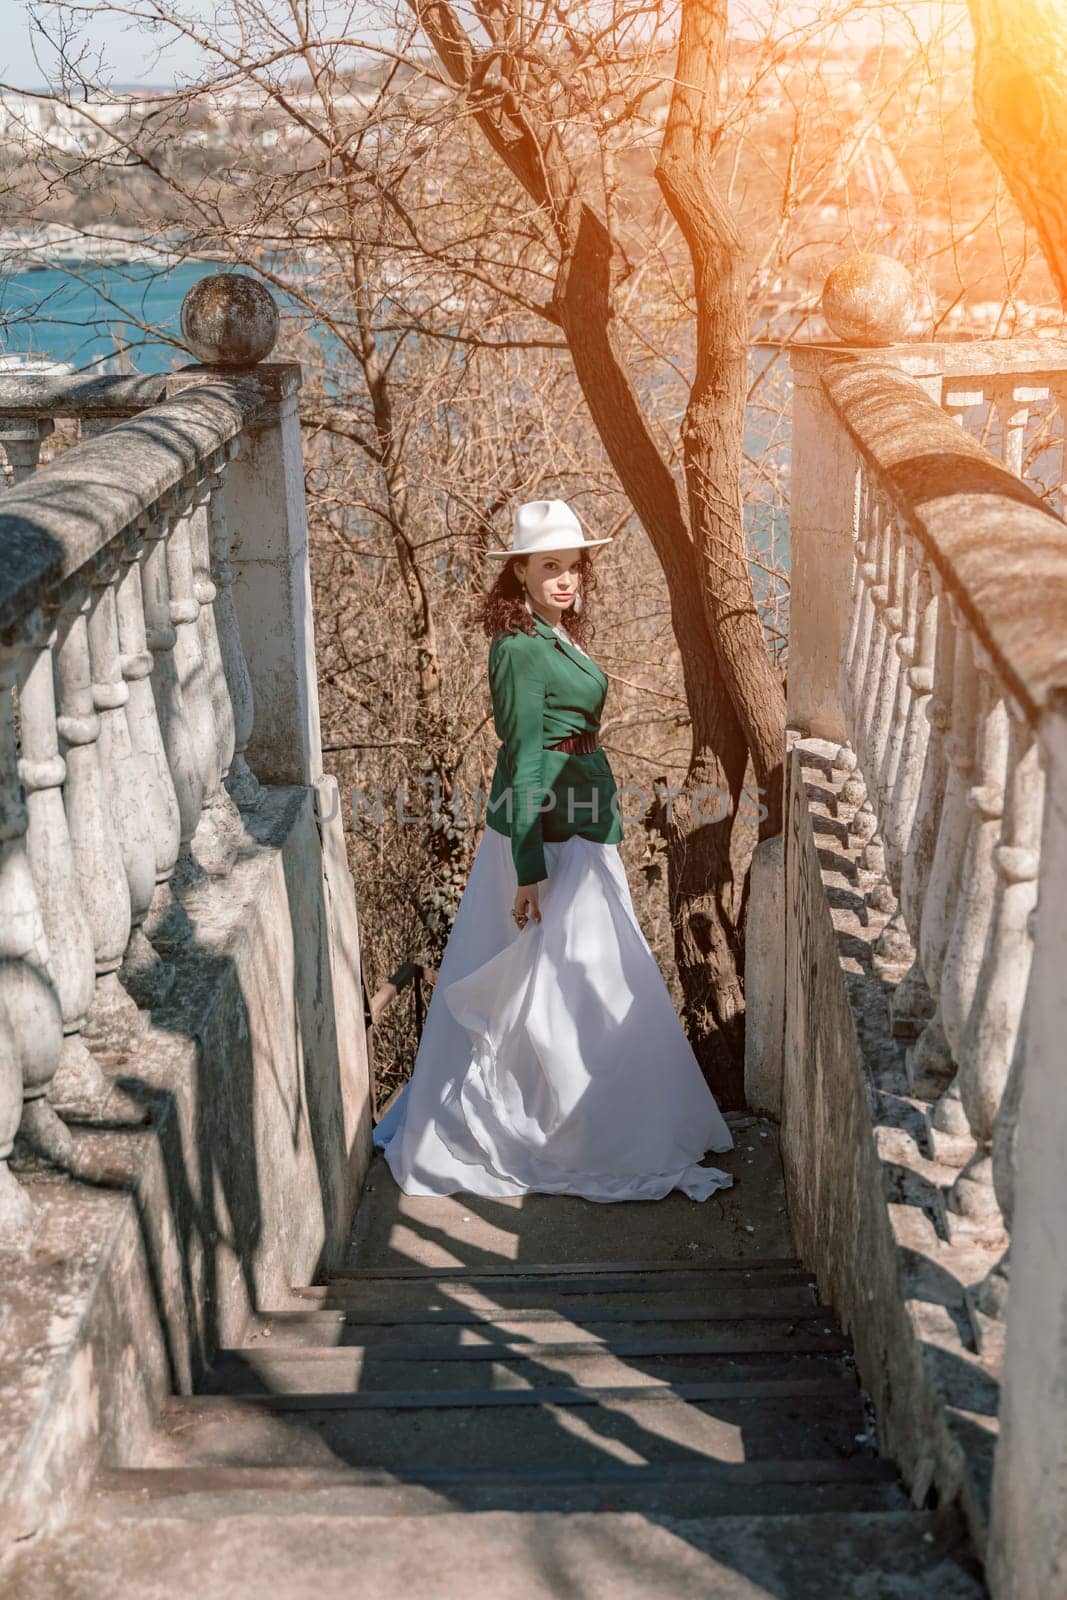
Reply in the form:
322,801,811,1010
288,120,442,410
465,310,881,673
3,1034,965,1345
0,278,320,1248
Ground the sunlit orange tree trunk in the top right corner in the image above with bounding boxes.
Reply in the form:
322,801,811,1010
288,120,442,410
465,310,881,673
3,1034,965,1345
969,0,1067,306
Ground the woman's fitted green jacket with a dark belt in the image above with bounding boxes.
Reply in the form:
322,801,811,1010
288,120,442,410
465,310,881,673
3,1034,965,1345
486,616,622,885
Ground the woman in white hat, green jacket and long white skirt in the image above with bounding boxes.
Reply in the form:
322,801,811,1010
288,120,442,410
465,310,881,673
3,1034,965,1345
374,501,733,1200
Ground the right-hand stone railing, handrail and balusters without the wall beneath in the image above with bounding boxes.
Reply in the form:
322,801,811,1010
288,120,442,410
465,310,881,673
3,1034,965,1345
790,341,1067,1336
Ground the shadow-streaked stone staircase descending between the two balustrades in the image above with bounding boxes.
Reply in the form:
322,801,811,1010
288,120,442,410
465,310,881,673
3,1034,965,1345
0,1128,984,1600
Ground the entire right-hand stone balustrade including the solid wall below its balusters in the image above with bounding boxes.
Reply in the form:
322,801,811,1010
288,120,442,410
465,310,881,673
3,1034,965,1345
777,312,1067,1595
